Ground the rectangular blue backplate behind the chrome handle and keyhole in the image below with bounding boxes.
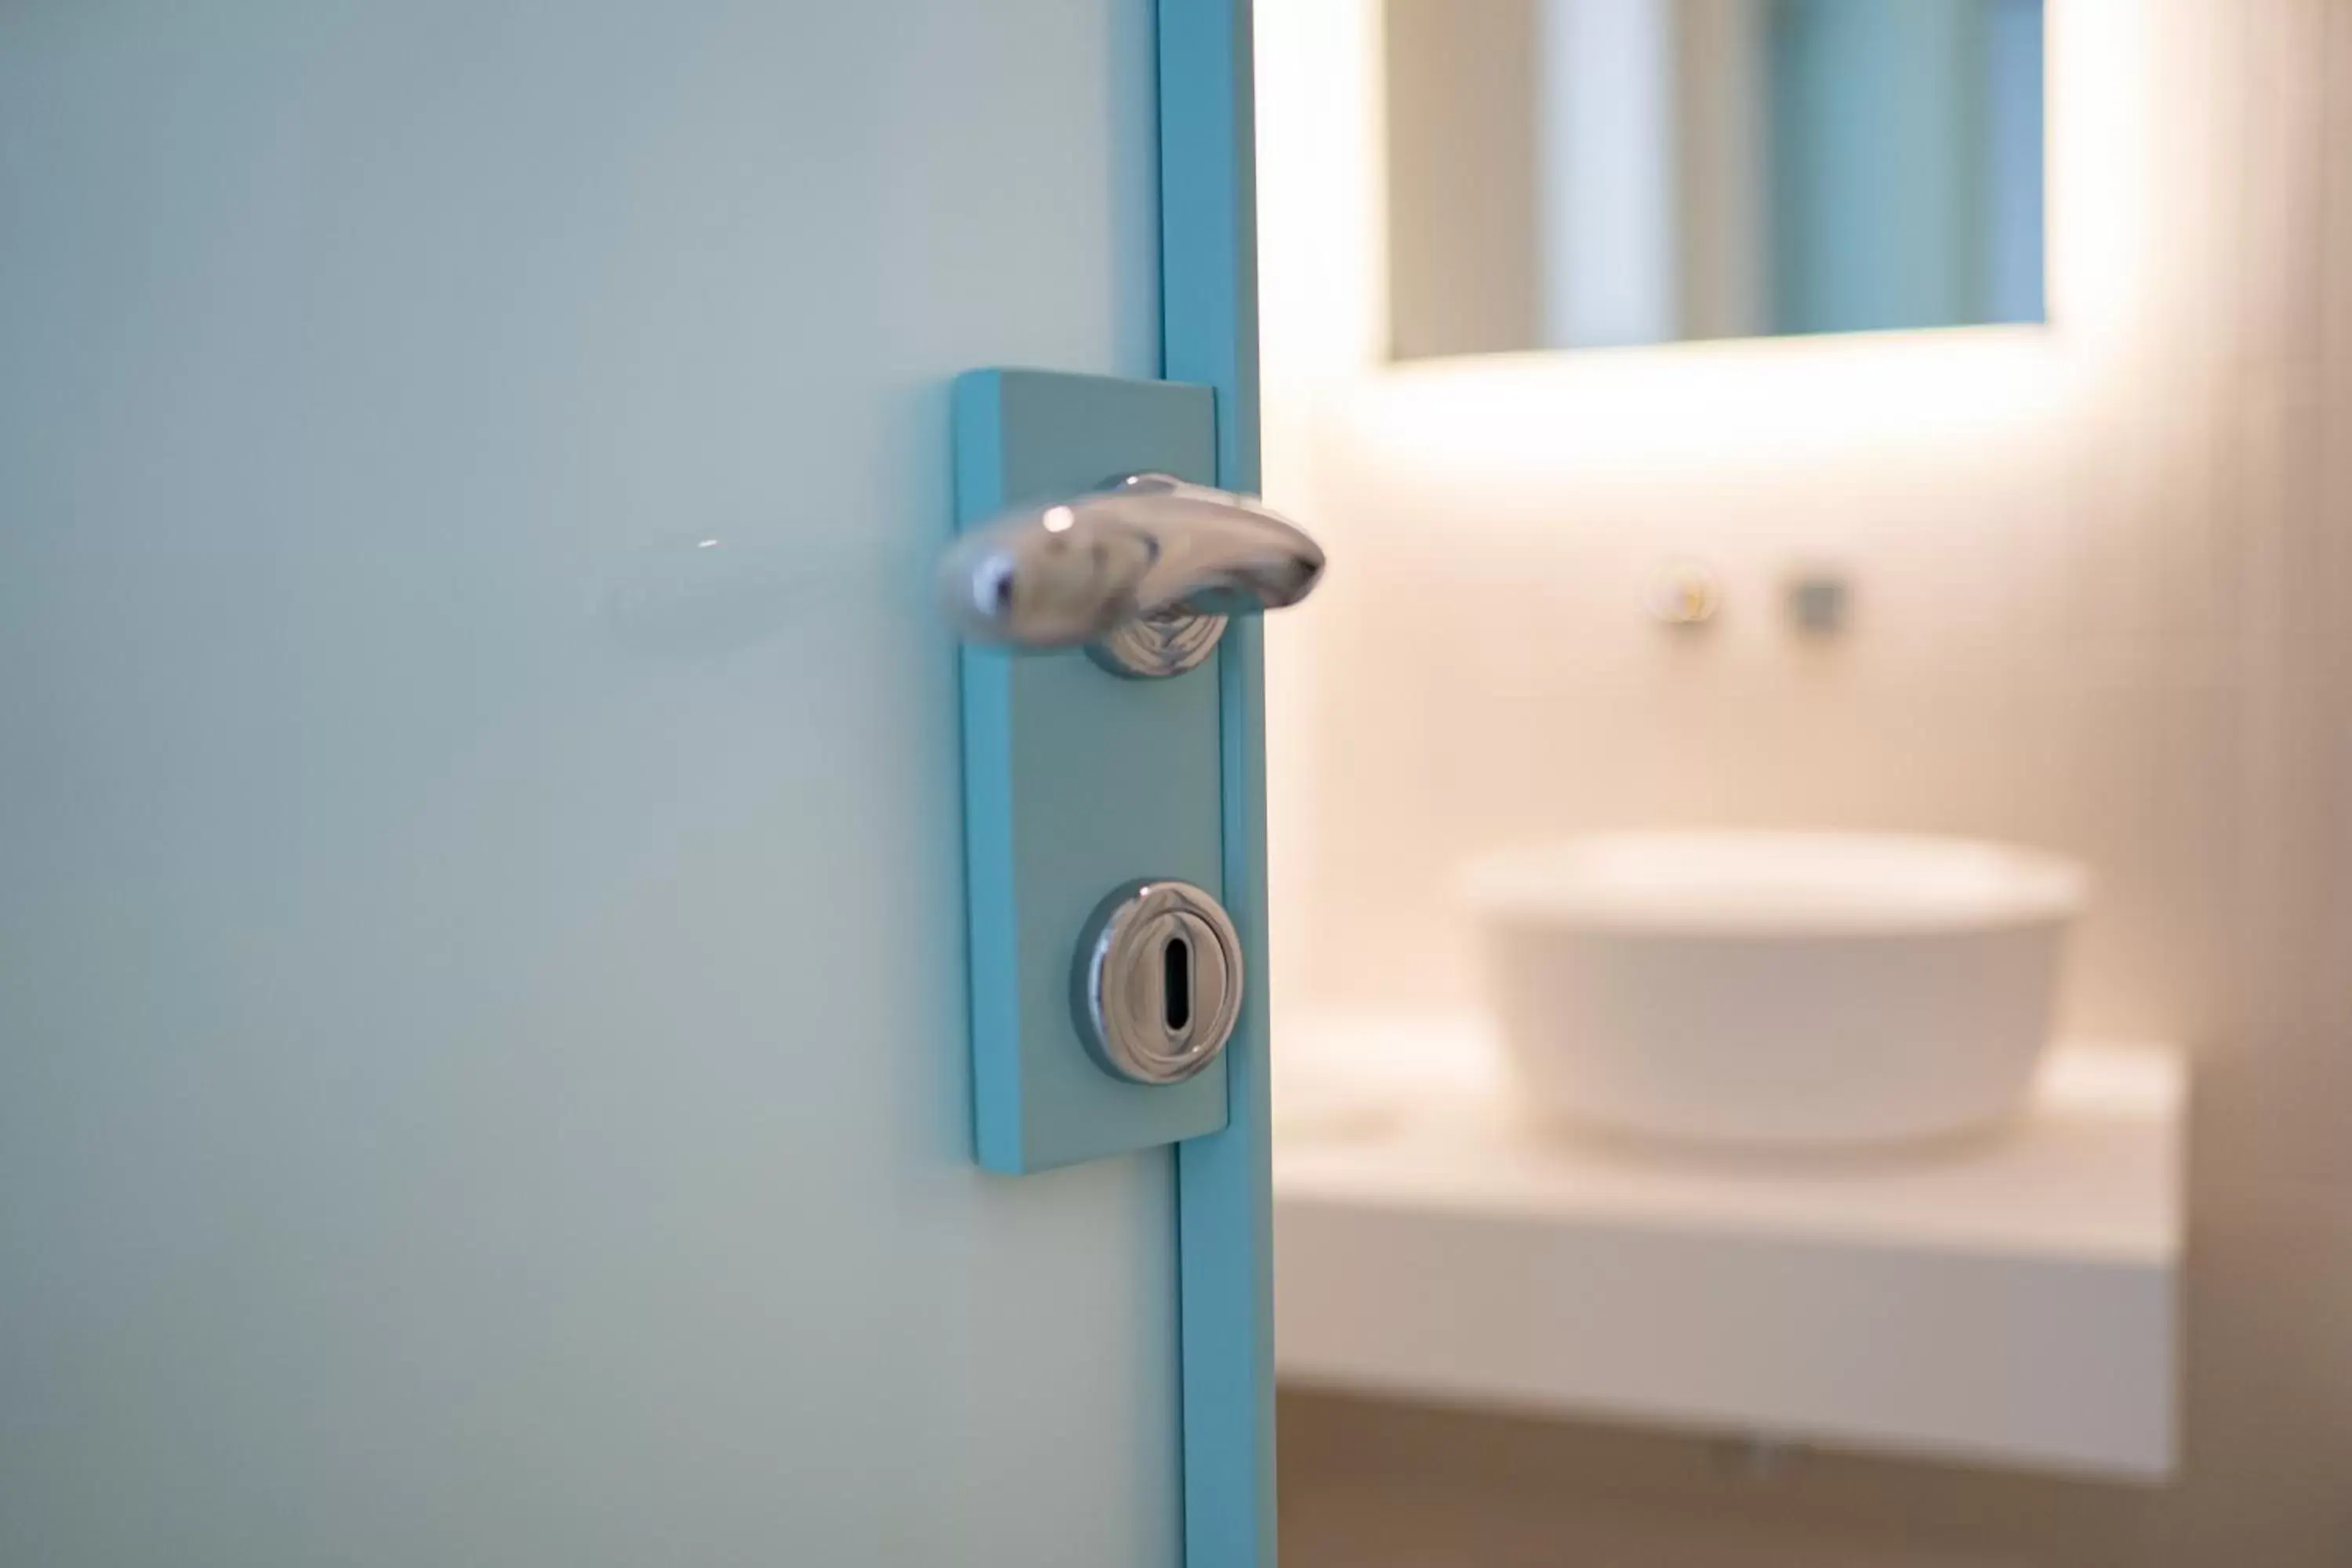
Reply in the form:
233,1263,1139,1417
955,369,1225,1173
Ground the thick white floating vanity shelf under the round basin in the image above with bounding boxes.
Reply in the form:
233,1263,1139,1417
1275,1022,2185,1481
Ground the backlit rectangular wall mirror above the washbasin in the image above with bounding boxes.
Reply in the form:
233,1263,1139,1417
1385,0,2044,360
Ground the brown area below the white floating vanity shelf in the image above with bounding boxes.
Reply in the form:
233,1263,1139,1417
1277,1389,2166,1568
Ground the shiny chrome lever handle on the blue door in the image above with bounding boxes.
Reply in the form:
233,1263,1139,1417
938,473,1324,677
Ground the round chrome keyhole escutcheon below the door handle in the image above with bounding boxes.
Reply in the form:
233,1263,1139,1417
1070,879,1242,1083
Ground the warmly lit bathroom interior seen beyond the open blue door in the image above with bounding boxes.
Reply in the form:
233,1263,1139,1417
1256,0,2352,1568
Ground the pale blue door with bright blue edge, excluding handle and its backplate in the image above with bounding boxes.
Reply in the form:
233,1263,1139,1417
0,0,1270,1568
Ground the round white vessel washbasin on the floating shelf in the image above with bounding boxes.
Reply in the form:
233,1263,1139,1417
1468,832,2086,1147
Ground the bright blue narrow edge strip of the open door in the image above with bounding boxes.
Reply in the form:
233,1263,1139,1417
1155,0,1275,1568
